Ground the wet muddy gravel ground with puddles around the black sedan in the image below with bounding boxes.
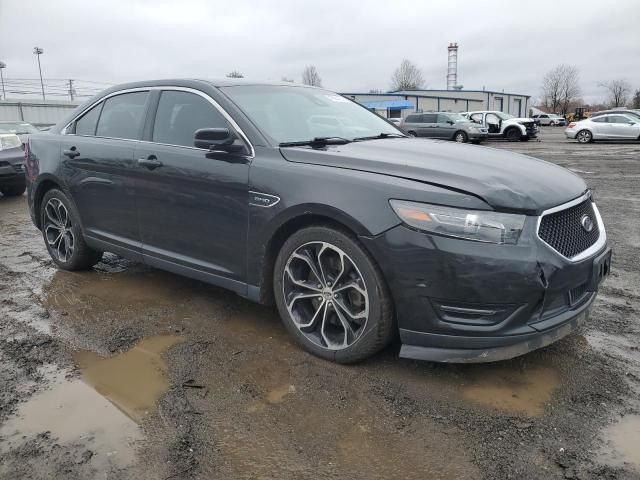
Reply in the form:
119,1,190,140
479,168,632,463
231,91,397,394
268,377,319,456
0,128,640,480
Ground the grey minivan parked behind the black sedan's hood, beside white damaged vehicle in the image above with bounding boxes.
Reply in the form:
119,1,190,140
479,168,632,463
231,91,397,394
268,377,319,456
400,112,489,143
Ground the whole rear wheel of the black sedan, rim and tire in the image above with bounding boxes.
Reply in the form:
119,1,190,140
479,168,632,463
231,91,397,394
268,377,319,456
40,189,102,270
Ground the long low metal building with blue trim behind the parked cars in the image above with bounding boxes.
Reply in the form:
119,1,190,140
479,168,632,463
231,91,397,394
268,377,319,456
342,90,531,118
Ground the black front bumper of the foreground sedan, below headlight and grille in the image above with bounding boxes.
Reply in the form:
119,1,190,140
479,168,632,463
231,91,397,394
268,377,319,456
363,217,608,362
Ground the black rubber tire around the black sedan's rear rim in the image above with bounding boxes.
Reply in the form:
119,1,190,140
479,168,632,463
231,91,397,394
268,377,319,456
40,188,102,271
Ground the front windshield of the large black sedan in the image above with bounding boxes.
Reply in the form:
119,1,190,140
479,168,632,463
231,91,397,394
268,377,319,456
221,85,402,143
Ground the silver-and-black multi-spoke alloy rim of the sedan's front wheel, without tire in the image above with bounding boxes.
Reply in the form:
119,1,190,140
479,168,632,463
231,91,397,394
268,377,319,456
282,242,369,350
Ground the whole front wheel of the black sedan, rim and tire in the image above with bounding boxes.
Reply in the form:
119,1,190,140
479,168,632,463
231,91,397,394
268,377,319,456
273,226,394,363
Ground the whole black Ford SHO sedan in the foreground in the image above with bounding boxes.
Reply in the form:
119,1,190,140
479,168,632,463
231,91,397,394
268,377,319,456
27,79,611,362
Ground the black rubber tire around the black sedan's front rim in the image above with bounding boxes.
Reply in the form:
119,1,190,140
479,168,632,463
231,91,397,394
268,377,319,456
273,226,396,363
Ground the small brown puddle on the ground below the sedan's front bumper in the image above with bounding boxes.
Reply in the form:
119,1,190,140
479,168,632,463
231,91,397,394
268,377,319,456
462,365,560,416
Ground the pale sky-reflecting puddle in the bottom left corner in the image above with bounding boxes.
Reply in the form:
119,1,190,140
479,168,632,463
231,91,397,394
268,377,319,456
0,366,142,471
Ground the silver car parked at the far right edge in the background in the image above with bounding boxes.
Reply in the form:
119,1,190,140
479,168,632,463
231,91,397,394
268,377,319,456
564,114,640,143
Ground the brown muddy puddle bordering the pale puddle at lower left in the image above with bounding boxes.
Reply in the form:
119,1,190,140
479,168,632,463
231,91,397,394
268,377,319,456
73,335,183,423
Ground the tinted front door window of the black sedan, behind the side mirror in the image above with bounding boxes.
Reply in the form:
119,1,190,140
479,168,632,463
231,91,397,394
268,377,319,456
152,90,231,147
